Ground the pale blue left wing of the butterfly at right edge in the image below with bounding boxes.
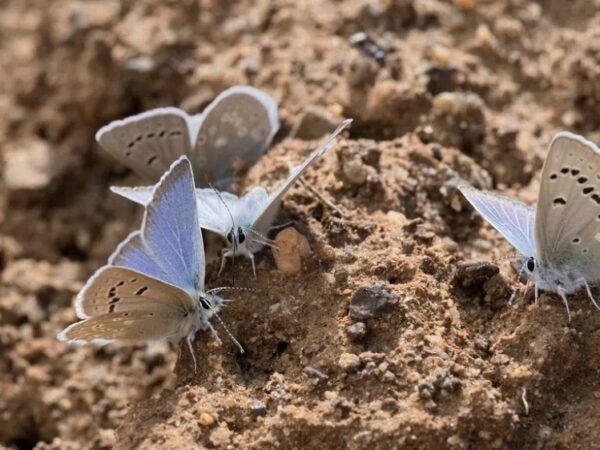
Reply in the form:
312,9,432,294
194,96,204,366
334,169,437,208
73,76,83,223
459,186,535,256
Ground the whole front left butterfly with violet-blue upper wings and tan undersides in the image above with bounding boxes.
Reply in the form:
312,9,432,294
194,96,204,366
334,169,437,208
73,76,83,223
57,156,234,369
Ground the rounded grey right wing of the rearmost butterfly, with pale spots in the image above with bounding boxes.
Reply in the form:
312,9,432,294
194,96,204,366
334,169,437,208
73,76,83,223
191,86,279,190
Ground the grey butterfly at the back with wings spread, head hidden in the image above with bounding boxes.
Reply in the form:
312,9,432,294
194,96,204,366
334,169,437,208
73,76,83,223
96,86,279,189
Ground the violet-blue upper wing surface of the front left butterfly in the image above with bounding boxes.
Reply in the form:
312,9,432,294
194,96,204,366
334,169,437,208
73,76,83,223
109,156,205,295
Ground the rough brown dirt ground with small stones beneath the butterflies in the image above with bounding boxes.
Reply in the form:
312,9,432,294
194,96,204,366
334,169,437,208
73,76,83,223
0,0,600,450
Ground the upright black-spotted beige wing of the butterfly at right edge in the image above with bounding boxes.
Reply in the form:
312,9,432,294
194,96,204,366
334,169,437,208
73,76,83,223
535,132,600,282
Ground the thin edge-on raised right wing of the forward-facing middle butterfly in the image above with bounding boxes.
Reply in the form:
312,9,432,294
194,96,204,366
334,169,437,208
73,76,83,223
252,119,352,235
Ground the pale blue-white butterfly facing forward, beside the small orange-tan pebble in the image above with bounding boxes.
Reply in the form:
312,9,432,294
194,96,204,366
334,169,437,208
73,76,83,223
111,119,352,278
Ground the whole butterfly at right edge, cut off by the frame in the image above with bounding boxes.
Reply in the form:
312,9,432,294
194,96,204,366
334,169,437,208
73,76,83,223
459,132,600,321
